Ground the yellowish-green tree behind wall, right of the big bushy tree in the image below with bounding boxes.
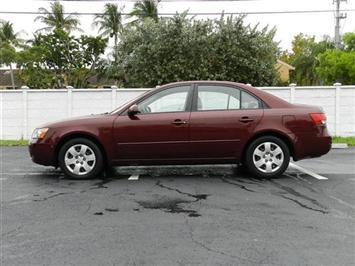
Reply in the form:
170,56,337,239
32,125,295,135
280,33,334,86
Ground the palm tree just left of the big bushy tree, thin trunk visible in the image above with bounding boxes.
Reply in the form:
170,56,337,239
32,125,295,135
93,4,123,49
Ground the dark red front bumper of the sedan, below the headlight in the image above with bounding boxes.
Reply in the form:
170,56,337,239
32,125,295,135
29,143,56,166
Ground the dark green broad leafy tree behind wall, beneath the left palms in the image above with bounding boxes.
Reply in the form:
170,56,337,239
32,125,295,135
19,29,107,88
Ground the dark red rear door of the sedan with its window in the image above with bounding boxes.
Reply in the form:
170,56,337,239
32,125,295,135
190,84,263,160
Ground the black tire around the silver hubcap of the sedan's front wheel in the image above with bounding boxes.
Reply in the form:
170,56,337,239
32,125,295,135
58,138,104,179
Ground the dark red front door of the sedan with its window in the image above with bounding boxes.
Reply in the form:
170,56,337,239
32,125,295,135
114,85,192,162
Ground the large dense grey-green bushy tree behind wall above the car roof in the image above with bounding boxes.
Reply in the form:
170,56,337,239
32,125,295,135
118,15,278,87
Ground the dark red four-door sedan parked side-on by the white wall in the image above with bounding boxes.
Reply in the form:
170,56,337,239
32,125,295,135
30,81,331,178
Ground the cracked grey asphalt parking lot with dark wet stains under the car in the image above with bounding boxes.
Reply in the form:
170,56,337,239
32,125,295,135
0,147,355,265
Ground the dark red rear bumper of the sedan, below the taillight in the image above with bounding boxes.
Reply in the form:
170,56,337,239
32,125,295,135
294,128,332,161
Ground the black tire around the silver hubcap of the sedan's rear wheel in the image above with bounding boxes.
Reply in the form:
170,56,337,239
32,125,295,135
245,136,290,178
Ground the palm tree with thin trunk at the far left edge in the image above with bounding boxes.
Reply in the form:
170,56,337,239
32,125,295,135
0,21,19,89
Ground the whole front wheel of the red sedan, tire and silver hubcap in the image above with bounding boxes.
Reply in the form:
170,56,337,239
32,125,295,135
58,138,103,179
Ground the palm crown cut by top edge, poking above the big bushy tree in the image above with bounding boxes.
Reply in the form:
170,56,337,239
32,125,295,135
130,0,159,21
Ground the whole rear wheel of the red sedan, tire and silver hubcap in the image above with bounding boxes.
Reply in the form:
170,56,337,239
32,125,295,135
246,136,290,178
